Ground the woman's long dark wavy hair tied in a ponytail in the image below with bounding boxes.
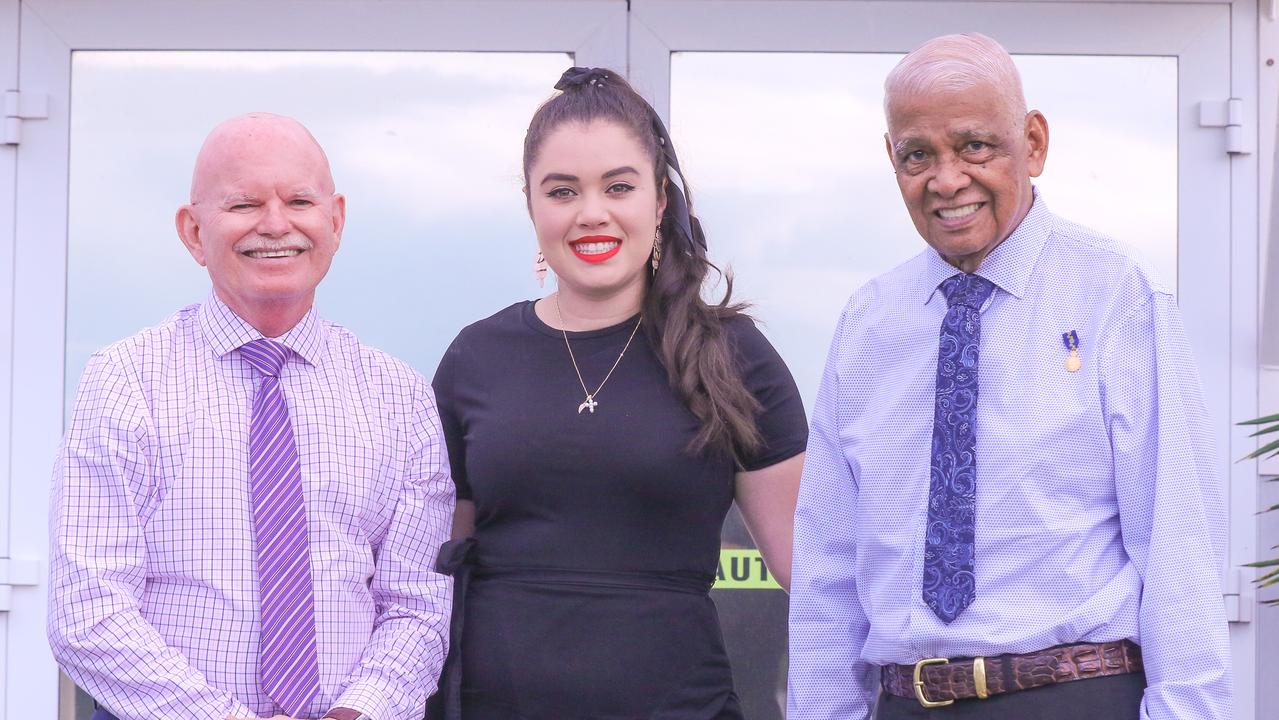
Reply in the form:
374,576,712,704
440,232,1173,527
524,68,762,464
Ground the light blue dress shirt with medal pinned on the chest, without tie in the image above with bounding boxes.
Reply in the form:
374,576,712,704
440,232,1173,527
788,193,1232,720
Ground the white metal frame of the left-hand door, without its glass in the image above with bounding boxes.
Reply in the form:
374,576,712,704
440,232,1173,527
7,0,627,719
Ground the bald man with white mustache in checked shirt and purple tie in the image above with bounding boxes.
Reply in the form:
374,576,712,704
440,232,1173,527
49,114,454,720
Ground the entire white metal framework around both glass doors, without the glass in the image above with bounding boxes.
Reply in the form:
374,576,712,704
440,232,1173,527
0,0,1279,720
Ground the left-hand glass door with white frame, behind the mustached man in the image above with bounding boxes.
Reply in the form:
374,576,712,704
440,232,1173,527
9,0,625,717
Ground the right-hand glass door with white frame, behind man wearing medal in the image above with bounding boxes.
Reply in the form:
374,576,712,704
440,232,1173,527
631,0,1256,720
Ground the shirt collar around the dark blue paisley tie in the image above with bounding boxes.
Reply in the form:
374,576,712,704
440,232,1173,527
921,188,1053,304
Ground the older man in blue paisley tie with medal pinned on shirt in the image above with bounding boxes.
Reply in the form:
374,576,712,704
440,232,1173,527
788,35,1230,720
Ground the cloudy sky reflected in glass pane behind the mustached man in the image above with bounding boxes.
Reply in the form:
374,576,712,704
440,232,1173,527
67,51,572,406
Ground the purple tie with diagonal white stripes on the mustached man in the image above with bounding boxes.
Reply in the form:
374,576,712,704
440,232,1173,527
240,339,320,716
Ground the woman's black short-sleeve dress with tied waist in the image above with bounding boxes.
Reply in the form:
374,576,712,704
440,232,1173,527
434,302,807,720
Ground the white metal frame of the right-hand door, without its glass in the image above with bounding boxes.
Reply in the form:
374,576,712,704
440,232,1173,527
629,0,1262,720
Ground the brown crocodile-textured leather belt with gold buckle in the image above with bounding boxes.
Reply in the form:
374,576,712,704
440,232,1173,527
880,639,1142,707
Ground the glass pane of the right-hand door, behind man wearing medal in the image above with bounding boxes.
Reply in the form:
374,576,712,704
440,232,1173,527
670,52,1177,720
